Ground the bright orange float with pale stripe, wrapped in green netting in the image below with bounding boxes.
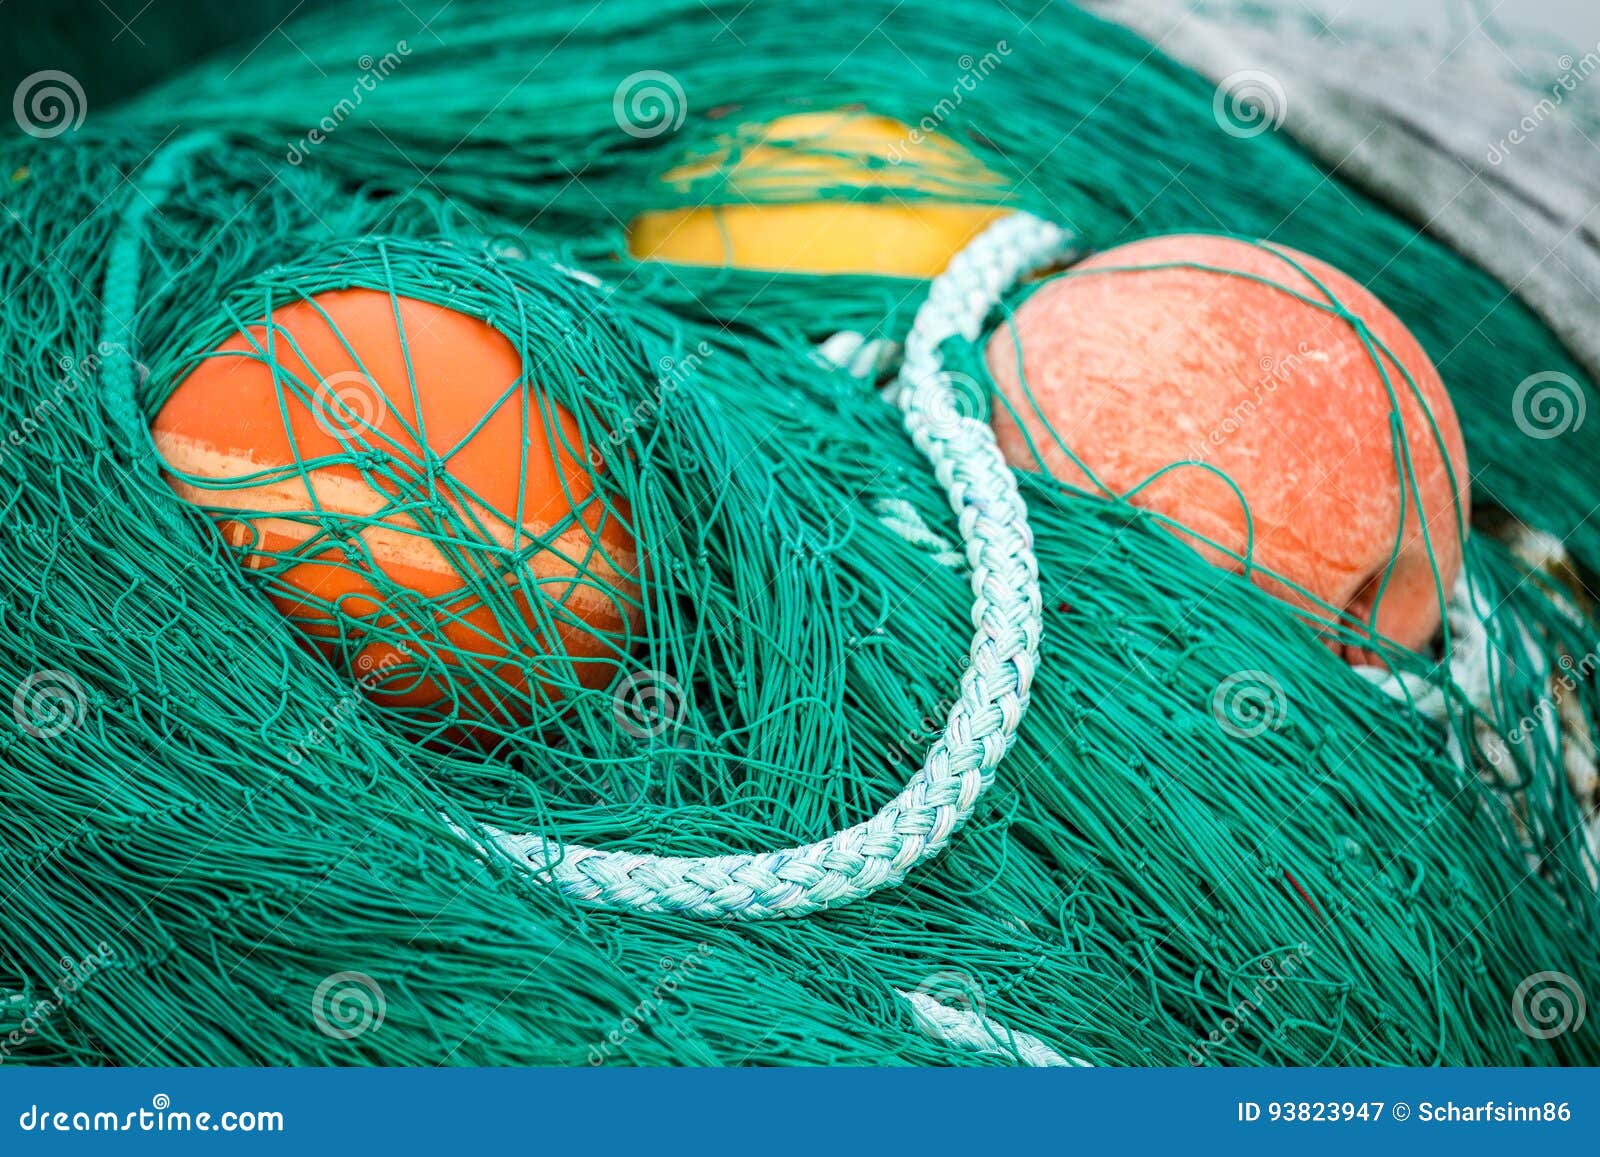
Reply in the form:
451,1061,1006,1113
152,290,638,723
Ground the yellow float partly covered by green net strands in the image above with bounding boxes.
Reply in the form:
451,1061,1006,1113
627,112,1003,277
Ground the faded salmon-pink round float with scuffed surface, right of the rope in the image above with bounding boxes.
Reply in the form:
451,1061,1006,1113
987,235,1469,659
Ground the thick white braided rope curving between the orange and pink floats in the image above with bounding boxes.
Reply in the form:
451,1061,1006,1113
483,214,1070,920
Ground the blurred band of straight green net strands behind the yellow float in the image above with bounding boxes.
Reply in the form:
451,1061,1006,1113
112,0,1600,568
